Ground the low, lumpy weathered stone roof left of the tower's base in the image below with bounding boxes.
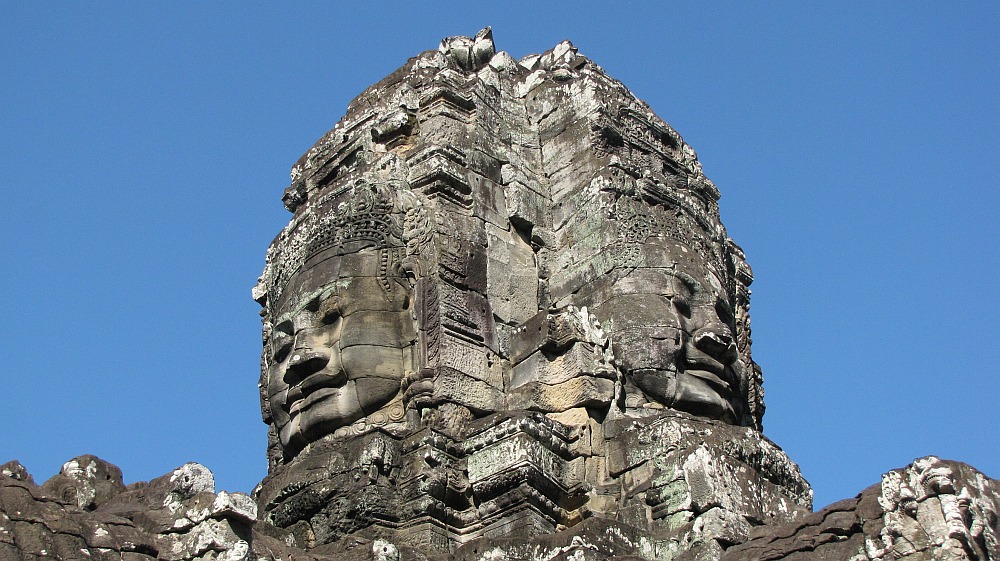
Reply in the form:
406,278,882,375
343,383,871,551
0,456,257,561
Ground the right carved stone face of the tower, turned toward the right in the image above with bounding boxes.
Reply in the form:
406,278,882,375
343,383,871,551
601,242,747,424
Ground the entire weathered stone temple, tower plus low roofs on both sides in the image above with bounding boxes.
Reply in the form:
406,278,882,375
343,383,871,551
0,28,1000,561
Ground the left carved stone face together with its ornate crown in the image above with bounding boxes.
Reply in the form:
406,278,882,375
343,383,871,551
257,176,428,457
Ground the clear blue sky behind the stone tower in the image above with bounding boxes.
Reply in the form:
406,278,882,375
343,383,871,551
0,1,1000,506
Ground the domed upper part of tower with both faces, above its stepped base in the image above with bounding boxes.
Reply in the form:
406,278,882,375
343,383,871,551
254,25,763,460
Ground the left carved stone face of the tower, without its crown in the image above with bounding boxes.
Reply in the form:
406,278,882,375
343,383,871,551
266,248,416,457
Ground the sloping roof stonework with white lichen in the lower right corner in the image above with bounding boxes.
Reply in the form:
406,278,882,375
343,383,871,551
722,456,1000,561
